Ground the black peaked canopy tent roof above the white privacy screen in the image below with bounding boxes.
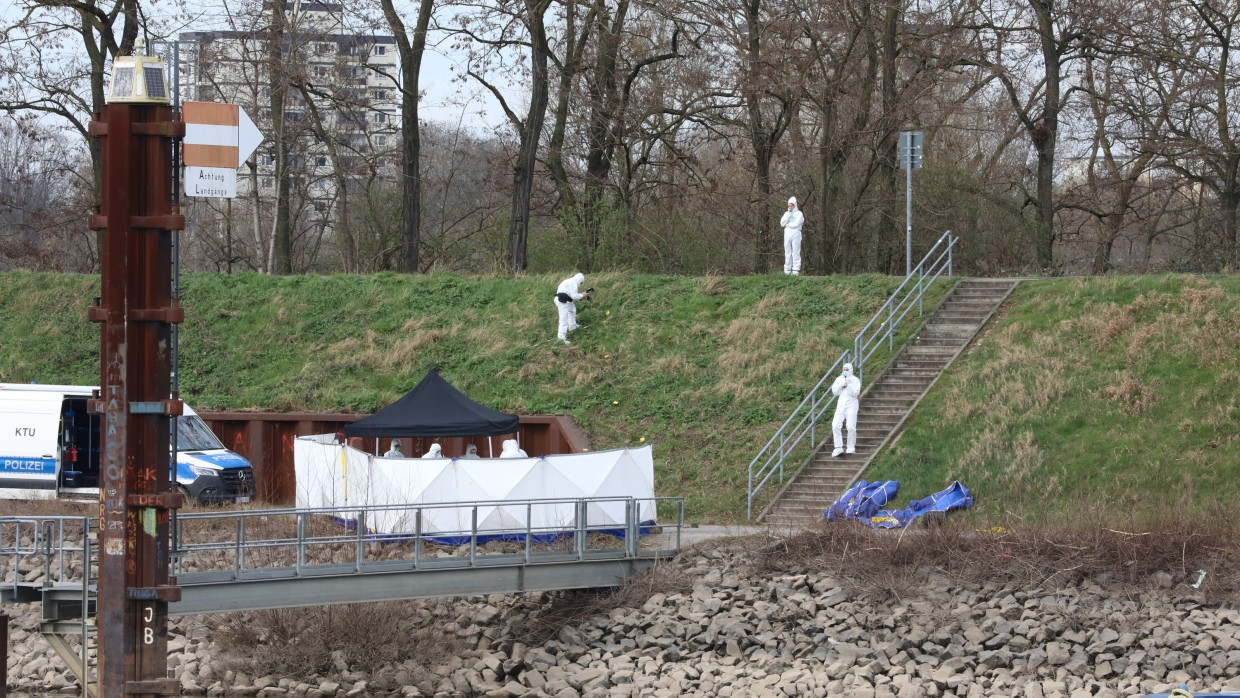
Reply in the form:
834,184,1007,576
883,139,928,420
345,371,521,438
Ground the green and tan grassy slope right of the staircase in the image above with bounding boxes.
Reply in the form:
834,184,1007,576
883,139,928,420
867,276,1240,523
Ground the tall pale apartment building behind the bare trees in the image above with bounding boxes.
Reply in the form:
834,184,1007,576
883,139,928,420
179,1,401,204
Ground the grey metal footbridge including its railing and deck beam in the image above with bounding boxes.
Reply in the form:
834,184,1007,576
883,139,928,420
0,497,684,619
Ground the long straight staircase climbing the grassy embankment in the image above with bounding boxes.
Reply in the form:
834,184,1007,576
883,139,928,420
760,279,1019,527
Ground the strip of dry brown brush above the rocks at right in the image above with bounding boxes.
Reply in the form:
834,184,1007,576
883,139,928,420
754,513,1240,600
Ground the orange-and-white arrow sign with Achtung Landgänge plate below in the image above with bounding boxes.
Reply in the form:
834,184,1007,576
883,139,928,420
181,102,263,198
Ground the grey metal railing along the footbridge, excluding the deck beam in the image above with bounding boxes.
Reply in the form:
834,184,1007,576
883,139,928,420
0,497,684,600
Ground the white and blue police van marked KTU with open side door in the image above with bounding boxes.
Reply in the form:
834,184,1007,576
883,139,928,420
0,383,254,503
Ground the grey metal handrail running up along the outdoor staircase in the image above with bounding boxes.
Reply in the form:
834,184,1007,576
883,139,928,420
745,231,960,519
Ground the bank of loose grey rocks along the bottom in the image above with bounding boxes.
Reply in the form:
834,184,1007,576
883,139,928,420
6,542,1240,698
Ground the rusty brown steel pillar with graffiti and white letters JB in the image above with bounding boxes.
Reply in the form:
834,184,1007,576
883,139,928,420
88,104,185,698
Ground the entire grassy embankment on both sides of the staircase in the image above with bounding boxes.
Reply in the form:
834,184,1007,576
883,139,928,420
0,273,1240,524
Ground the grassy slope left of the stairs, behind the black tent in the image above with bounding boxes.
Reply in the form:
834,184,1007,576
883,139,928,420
0,273,946,522
